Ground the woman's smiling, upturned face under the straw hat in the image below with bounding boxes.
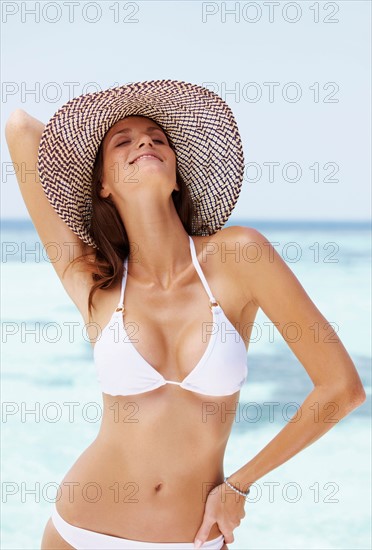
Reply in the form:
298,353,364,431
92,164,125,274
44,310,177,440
100,116,179,203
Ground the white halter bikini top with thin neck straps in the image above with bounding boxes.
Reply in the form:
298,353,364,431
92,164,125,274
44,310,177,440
93,236,248,396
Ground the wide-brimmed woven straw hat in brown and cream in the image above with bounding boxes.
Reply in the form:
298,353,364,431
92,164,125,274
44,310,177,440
38,80,244,248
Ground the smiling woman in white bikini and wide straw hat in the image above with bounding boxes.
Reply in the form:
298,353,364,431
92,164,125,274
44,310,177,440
6,80,365,549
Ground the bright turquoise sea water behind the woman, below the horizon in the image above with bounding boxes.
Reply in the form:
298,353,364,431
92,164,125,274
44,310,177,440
1,220,372,550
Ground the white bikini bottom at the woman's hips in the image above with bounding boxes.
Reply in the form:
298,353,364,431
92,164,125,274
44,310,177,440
52,504,224,550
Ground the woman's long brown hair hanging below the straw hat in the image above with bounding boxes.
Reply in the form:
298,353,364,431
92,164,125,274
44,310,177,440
69,121,201,316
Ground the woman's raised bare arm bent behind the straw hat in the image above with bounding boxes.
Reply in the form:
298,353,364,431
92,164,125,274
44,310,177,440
5,109,94,319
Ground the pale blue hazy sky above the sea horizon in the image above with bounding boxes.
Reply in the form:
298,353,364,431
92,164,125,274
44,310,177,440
1,0,371,221
